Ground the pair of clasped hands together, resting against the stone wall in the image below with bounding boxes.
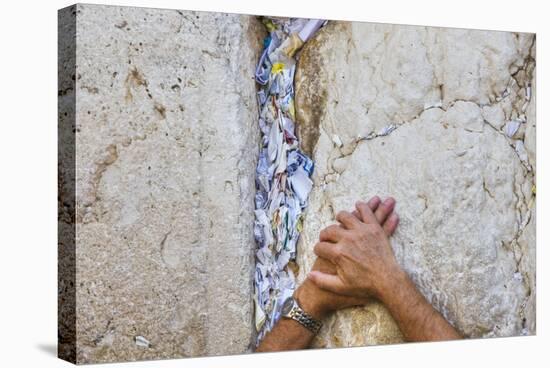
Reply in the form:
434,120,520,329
295,196,403,318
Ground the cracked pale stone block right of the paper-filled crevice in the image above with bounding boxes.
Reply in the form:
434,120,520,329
296,22,535,347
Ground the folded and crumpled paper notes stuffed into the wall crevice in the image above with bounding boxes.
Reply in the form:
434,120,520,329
254,18,326,343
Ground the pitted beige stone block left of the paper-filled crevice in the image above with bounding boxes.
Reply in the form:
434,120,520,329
63,5,264,363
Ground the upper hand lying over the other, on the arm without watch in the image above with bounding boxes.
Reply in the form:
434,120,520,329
308,198,404,300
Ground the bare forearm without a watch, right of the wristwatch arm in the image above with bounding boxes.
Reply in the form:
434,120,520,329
381,271,462,341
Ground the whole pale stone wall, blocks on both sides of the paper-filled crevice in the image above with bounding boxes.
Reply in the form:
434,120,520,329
59,5,535,363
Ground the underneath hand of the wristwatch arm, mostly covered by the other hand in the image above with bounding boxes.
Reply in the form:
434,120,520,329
294,196,399,319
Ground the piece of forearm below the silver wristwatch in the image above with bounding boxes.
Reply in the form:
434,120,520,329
256,318,314,352
